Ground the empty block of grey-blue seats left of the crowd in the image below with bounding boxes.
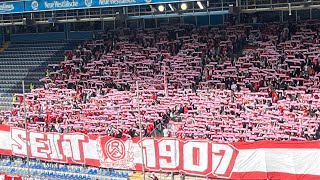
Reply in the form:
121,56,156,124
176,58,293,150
0,41,80,109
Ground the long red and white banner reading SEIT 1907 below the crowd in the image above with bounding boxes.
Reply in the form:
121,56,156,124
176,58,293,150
0,125,320,180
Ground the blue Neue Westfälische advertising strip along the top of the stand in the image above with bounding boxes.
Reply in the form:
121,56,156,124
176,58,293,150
0,0,188,14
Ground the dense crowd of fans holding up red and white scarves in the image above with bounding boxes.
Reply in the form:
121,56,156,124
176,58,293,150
0,22,320,142
